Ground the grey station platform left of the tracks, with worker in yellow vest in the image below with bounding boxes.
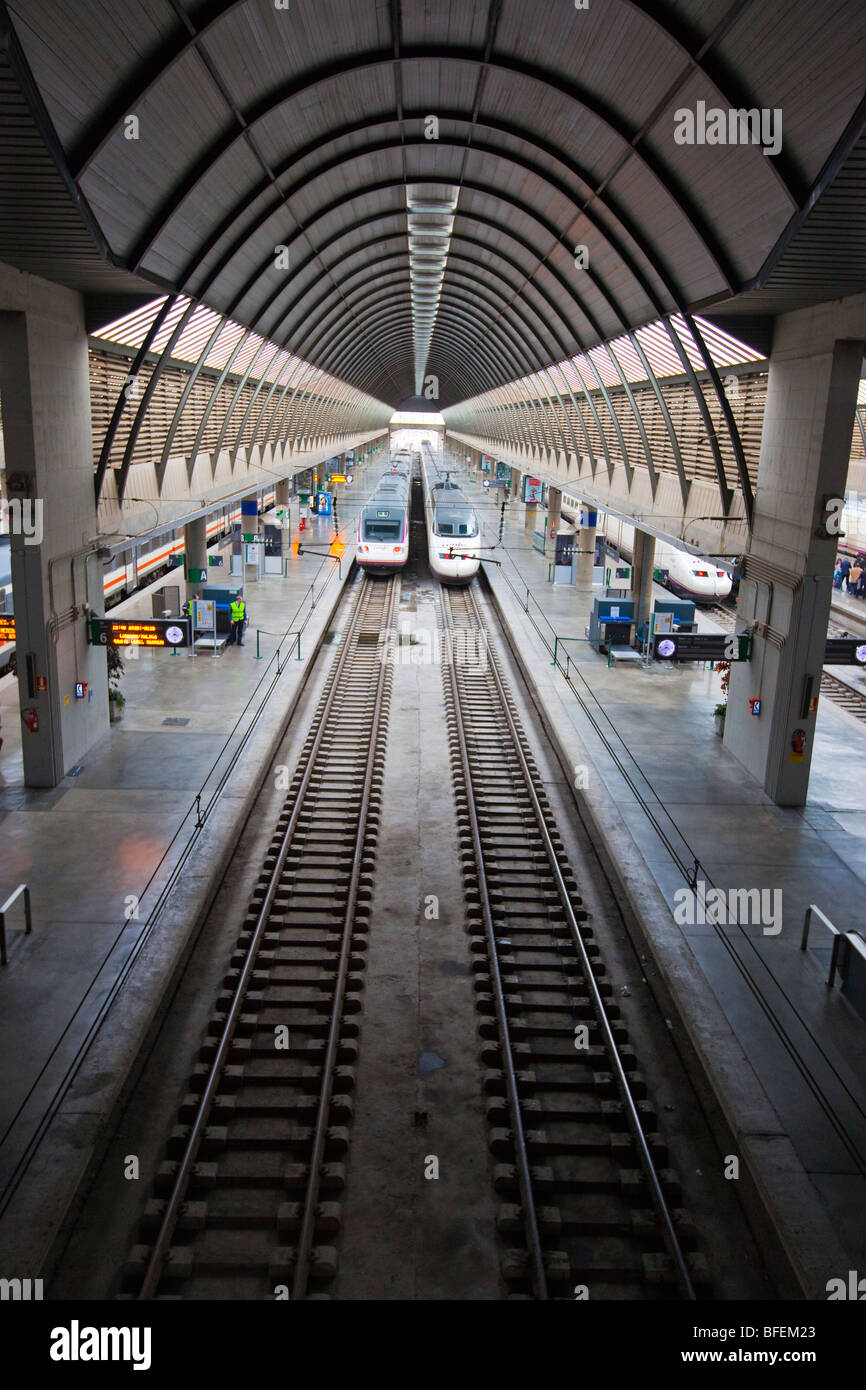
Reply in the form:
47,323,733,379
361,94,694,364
0,475,372,1273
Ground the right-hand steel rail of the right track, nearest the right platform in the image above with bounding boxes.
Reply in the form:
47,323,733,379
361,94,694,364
466,589,696,1300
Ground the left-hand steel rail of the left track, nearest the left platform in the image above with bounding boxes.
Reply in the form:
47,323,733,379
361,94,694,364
138,569,386,1300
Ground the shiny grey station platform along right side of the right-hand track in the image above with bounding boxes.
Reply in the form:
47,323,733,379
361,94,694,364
455,461,866,1298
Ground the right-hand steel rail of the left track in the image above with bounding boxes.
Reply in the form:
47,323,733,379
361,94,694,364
292,569,398,1298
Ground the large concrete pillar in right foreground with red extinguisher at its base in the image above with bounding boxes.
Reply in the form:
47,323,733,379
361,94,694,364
724,296,866,806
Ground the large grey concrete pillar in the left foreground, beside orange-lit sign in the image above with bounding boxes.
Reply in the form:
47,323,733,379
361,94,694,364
0,265,108,787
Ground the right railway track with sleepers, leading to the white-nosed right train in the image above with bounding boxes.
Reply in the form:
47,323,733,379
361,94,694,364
442,589,709,1298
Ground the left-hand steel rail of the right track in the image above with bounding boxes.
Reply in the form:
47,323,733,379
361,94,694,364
441,588,549,1300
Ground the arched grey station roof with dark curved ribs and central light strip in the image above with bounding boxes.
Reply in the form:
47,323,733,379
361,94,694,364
0,0,866,409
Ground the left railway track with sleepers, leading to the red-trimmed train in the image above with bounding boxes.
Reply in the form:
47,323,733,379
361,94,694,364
125,578,399,1298
